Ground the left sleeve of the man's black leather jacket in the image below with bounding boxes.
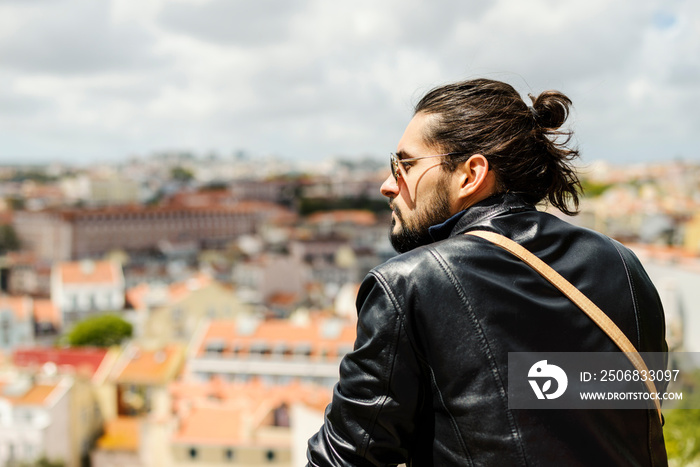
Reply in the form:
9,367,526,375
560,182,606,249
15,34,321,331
307,271,423,466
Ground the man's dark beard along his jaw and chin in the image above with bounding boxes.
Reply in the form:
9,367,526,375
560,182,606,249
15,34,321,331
389,178,451,253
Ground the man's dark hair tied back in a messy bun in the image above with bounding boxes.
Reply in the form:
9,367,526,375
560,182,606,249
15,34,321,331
415,79,581,215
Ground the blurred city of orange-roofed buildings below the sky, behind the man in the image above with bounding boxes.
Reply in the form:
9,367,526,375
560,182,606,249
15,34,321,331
0,152,700,467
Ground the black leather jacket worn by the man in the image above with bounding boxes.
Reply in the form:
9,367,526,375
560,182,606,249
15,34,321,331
307,194,667,466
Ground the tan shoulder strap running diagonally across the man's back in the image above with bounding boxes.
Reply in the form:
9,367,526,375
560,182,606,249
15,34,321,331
467,230,663,424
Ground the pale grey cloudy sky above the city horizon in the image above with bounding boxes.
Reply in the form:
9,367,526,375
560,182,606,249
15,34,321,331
0,0,700,164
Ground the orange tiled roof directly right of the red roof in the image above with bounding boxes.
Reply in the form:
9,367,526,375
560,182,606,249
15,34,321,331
112,344,183,385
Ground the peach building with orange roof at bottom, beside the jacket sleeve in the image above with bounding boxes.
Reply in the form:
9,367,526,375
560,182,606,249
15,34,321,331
168,378,331,467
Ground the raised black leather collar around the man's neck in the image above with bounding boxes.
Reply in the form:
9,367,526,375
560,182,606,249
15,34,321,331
428,193,535,242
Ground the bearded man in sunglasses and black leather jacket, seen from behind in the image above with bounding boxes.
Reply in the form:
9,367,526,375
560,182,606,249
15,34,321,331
308,79,667,466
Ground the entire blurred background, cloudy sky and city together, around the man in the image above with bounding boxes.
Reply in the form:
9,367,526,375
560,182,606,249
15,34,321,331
0,0,700,467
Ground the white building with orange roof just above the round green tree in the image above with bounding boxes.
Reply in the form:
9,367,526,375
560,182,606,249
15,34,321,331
51,259,125,326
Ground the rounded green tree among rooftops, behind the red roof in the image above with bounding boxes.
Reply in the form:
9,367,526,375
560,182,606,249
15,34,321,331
67,314,133,347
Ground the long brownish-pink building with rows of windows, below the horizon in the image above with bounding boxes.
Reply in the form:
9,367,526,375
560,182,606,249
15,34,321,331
13,201,288,261
